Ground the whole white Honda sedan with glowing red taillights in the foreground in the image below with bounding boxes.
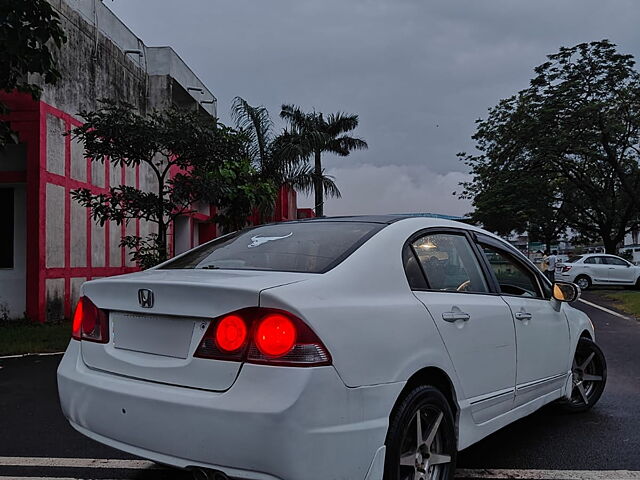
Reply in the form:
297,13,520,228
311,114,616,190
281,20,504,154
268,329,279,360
58,216,606,480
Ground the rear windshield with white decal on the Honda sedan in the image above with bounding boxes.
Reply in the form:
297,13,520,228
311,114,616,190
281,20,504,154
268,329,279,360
160,221,385,273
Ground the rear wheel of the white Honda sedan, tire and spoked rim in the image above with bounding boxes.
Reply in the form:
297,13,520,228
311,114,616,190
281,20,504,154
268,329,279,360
384,385,457,480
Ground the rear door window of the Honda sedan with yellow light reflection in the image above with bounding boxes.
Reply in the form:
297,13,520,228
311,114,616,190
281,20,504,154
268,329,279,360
412,233,489,293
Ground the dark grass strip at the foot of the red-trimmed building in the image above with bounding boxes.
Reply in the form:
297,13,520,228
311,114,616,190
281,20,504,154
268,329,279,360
0,320,71,355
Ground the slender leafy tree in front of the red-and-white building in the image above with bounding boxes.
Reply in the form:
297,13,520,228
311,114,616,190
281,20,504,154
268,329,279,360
71,101,272,267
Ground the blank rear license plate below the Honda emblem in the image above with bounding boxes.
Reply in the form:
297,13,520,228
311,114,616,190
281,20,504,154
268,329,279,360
110,312,195,358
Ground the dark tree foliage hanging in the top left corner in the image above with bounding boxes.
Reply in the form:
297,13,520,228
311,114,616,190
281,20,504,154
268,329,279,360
0,0,67,147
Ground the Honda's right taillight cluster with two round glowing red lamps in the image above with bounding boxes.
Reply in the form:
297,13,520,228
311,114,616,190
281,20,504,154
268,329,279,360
195,307,331,367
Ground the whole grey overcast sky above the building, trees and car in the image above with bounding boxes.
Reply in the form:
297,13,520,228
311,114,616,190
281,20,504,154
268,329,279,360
109,0,640,215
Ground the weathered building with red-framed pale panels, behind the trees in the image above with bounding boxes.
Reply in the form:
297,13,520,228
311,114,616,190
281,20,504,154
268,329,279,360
0,0,297,321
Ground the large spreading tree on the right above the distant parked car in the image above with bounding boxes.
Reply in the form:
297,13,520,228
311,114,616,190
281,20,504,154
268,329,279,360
460,40,640,252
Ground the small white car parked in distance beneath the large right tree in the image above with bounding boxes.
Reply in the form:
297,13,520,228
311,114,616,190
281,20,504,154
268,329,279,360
555,253,640,290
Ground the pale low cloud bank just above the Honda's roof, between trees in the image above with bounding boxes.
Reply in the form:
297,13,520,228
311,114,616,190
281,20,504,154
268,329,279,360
298,164,471,215
